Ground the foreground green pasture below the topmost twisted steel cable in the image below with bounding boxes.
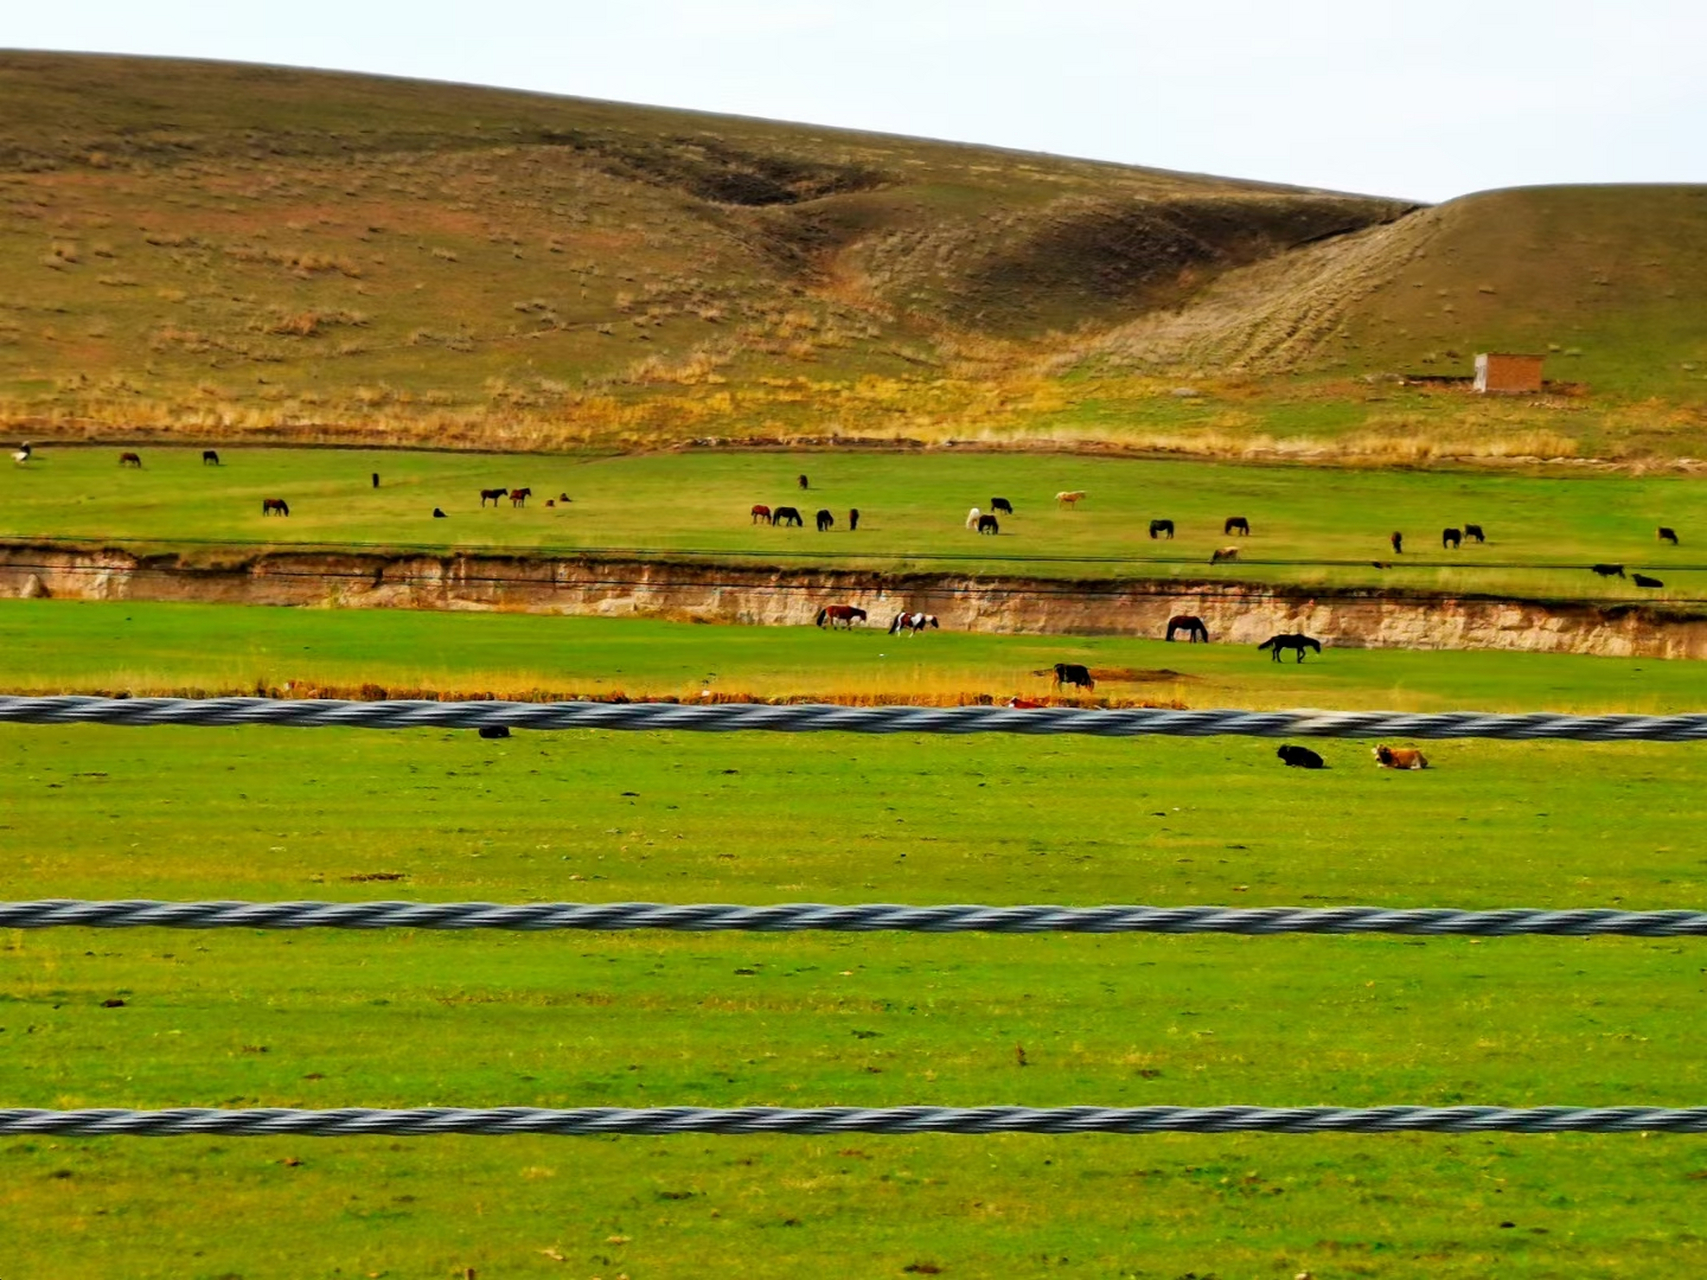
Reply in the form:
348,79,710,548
0,725,1707,1278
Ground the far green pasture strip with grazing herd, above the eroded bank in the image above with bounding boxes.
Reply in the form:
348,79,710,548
0,447,1707,599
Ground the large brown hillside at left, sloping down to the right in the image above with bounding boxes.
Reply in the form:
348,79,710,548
0,53,1408,430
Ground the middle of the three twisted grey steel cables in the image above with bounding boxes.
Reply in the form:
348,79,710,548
10,898,1707,937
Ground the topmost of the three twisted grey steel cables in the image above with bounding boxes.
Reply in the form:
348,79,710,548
0,695,1707,742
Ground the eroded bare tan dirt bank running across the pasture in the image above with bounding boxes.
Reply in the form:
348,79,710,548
0,543,1707,657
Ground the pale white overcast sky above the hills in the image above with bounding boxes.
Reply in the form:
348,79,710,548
0,0,1707,200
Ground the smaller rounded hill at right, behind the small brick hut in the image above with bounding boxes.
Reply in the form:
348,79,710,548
1104,186,1707,401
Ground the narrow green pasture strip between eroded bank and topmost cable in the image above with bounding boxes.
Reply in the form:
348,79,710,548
0,601,1704,713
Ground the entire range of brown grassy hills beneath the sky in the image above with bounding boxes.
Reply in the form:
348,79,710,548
0,53,1707,447
